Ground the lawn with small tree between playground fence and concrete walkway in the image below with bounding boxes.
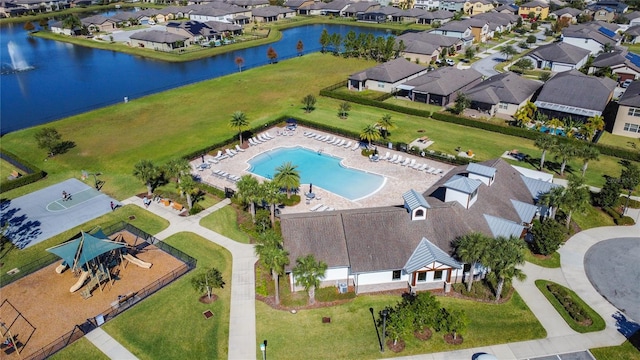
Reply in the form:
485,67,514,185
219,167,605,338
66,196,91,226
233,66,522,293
103,233,232,359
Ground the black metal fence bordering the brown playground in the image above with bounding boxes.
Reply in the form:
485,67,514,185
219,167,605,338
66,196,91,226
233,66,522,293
13,222,197,360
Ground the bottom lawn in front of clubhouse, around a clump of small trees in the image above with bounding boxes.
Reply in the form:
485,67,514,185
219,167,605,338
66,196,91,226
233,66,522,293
256,293,546,360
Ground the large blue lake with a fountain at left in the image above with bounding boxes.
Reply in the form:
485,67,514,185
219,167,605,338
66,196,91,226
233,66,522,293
0,23,387,134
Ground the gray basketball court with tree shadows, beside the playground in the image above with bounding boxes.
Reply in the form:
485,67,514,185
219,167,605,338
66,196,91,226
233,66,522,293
2,179,118,249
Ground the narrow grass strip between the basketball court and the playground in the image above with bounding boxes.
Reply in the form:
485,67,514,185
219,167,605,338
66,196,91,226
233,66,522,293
0,205,169,285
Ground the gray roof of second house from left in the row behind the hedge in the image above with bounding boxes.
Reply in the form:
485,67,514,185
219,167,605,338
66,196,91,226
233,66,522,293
405,67,482,96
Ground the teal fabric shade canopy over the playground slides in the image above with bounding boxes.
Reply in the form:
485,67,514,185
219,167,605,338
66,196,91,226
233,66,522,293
47,230,125,269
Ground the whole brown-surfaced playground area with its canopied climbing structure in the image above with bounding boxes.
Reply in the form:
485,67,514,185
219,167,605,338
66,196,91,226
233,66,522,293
0,230,184,359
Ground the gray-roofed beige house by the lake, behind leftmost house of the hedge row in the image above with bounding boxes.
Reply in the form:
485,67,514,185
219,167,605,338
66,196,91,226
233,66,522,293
396,31,463,64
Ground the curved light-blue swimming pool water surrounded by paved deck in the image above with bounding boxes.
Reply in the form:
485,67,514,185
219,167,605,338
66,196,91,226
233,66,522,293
249,147,385,200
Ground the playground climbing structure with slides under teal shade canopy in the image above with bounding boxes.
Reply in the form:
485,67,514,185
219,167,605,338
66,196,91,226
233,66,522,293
47,229,152,299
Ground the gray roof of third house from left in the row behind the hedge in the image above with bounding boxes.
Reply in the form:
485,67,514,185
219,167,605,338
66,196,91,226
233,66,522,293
465,72,542,105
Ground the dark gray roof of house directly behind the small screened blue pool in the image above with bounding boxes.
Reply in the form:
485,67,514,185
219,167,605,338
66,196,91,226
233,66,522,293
535,70,617,112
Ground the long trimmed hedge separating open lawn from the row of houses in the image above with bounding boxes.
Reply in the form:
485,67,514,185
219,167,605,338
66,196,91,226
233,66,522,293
320,81,640,161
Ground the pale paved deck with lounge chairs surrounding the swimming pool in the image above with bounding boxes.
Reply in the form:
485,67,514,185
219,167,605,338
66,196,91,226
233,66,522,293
191,126,453,213
